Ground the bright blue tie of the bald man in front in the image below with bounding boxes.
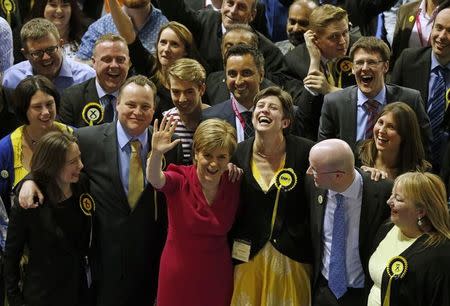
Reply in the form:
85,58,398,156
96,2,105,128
328,193,347,299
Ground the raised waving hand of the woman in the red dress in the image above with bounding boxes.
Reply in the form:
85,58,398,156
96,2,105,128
152,116,181,155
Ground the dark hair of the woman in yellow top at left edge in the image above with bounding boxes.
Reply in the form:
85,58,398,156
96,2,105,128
13,75,61,124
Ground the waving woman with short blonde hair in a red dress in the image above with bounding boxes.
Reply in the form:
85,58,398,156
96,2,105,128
147,118,239,306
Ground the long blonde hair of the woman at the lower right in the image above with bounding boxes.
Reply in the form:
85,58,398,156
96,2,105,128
394,172,450,246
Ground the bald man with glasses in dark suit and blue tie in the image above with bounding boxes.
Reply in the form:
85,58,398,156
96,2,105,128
306,139,392,306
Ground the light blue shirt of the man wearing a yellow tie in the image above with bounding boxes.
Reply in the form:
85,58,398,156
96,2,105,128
116,120,149,195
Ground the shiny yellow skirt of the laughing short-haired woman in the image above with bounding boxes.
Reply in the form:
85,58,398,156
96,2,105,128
231,242,312,306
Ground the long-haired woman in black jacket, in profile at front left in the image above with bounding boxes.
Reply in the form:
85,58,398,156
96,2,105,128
5,131,94,306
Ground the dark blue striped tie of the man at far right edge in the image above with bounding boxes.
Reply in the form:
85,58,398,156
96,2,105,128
428,66,446,165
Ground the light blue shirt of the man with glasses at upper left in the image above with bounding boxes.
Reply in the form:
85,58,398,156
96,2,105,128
3,57,95,93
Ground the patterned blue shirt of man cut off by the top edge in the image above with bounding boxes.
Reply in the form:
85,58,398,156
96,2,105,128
77,6,168,60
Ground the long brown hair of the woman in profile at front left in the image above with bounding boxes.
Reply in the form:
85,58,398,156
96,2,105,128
30,131,77,204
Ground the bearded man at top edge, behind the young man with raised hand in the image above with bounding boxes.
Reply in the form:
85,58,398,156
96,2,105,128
275,0,317,54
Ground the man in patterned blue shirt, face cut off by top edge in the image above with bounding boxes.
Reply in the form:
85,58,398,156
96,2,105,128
77,0,167,61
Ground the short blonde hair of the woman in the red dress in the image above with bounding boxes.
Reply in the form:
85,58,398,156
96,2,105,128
192,119,237,157
